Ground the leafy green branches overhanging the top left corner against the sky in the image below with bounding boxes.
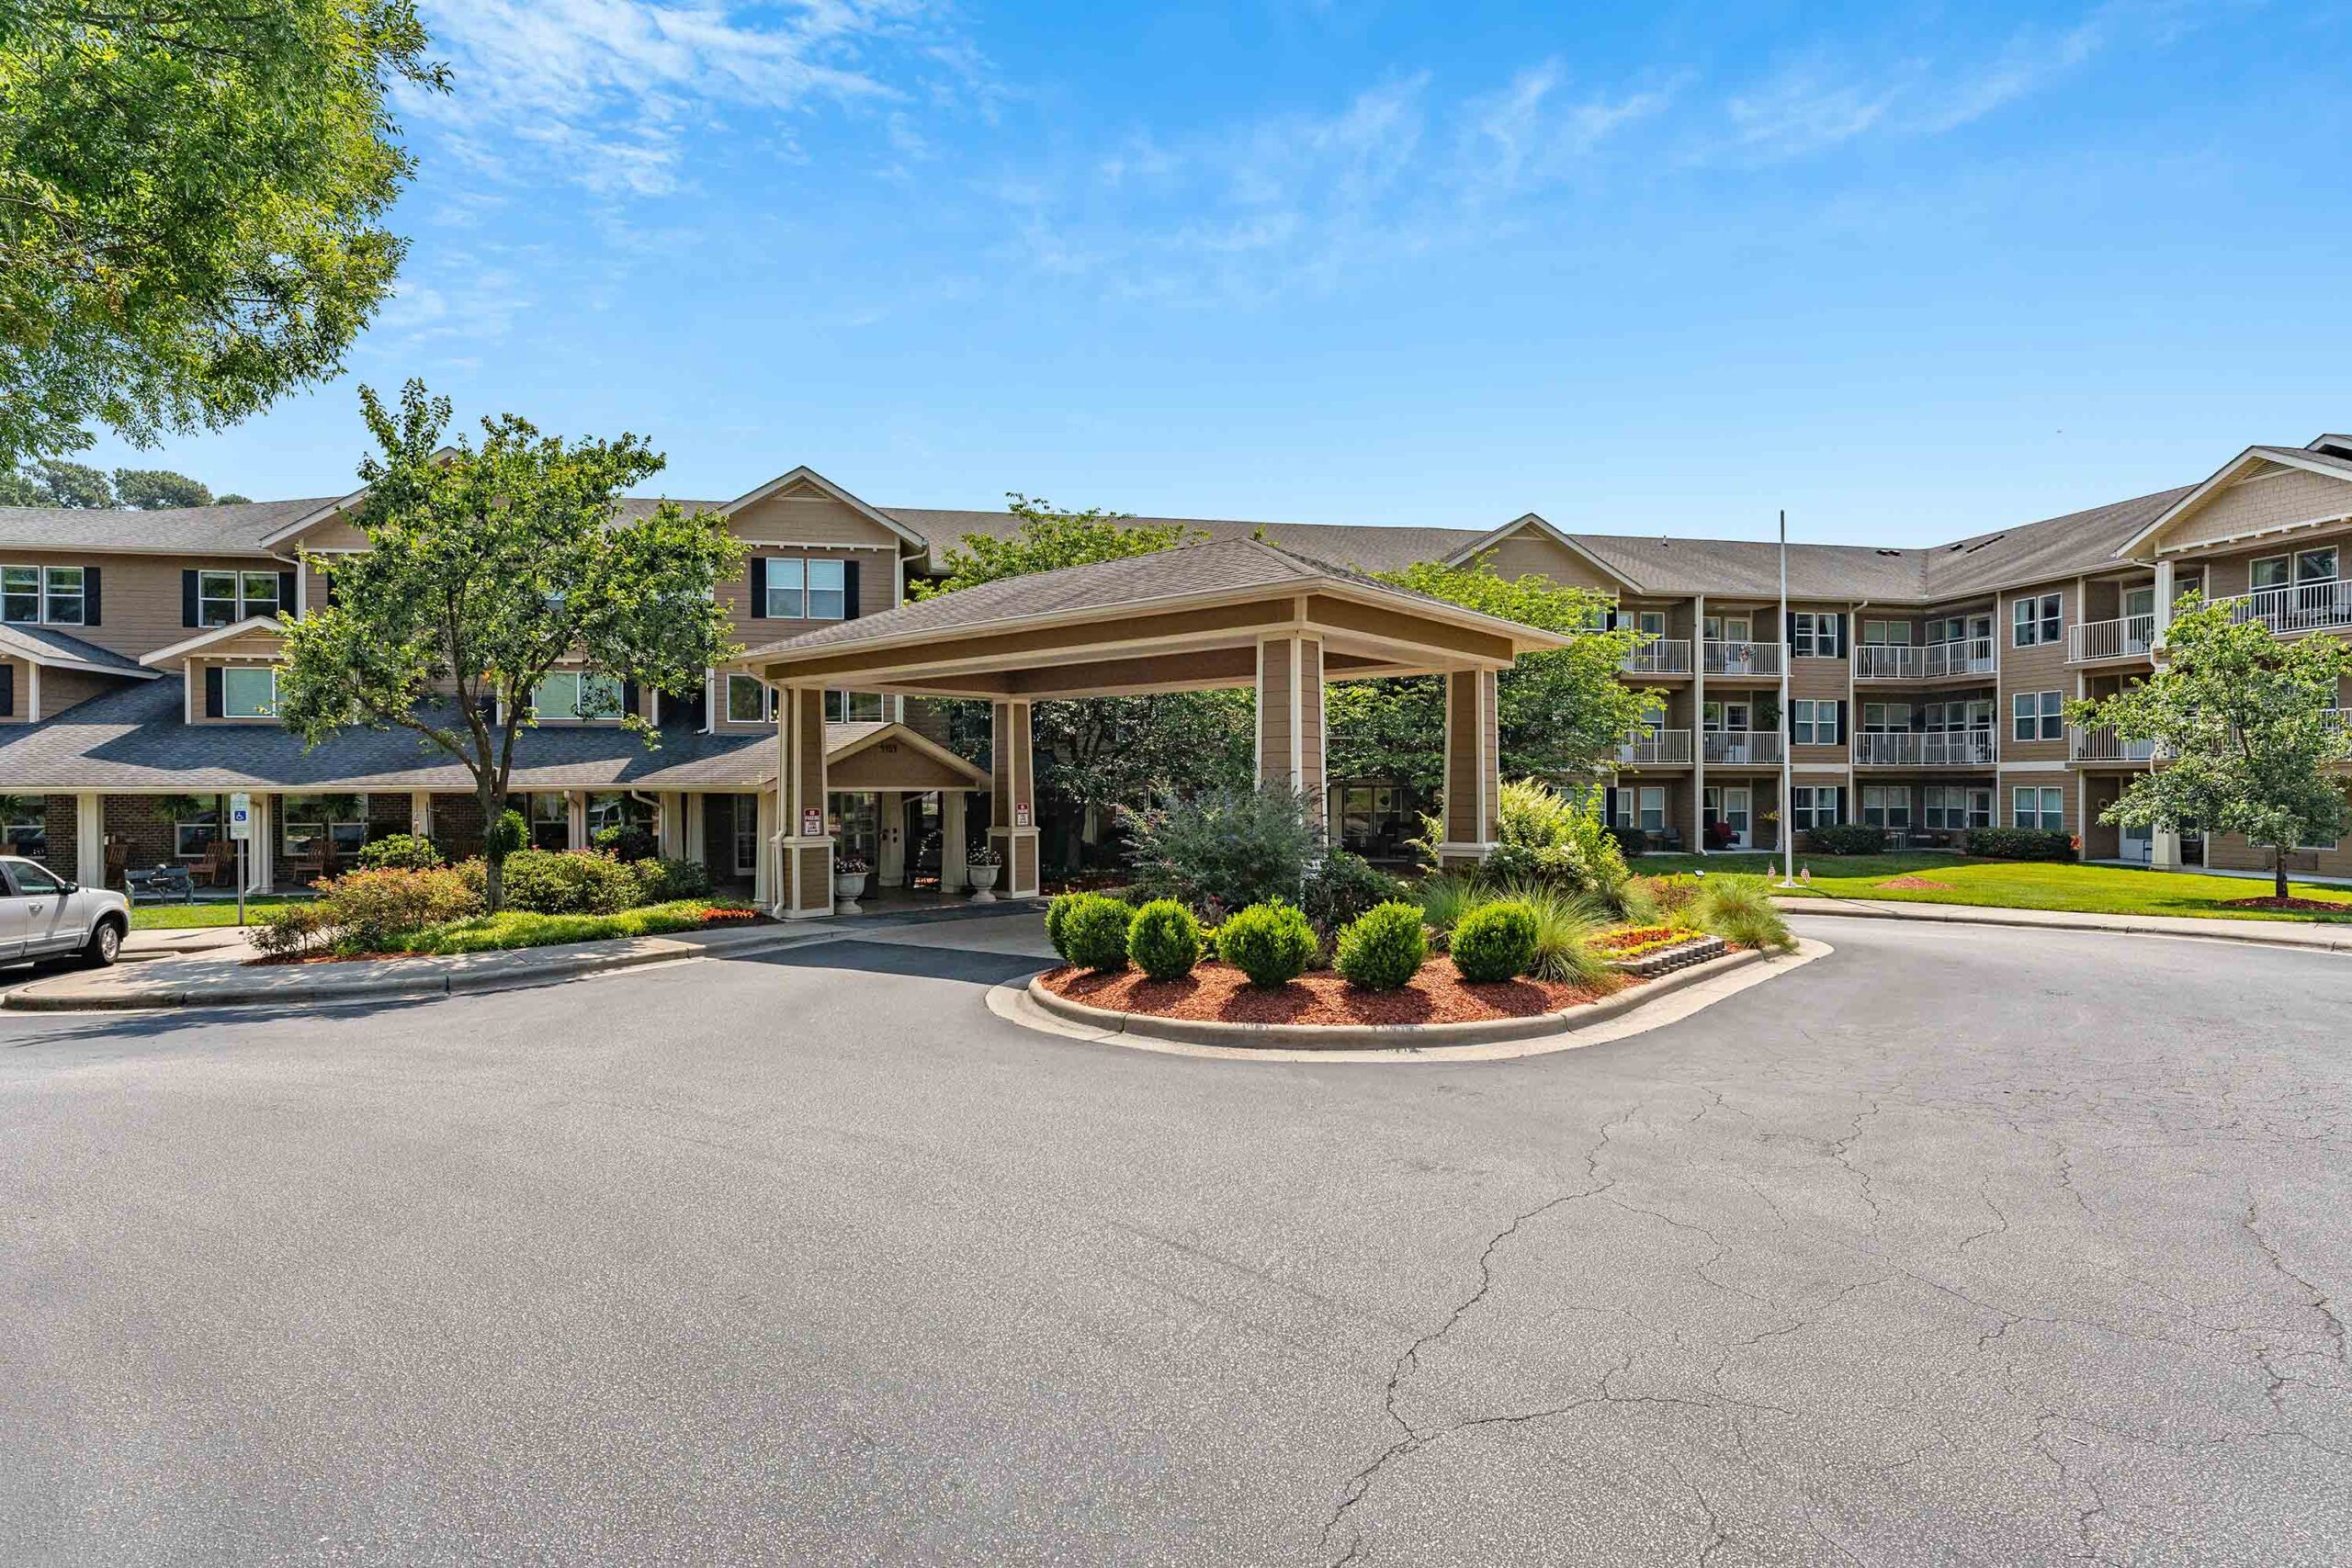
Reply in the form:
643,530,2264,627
0,0,447,466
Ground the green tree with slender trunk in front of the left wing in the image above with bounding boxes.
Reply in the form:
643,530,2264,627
277,381,746,909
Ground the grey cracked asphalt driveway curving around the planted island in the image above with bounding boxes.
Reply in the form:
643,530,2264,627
0,919,2352,1568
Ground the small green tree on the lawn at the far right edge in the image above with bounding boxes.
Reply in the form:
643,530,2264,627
2067,594,2352,898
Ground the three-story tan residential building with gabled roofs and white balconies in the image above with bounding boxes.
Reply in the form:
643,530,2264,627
0,434,2352,896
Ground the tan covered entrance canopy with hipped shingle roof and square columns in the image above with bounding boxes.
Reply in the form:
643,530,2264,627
736,538,1566,919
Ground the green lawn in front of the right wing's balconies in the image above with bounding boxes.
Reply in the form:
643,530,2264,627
1633,853,2352,924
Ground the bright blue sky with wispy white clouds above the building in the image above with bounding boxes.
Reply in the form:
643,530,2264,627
74,0,2352,543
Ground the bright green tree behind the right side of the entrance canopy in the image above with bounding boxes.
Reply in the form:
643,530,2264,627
1324,562,1658,795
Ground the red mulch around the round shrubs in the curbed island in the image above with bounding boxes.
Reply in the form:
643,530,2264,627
1045,962,1627,1022
